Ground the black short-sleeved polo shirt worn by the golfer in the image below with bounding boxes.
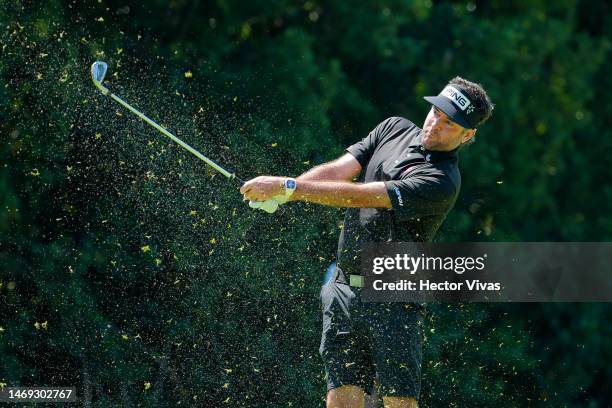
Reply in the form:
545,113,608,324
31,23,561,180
338,117,461,274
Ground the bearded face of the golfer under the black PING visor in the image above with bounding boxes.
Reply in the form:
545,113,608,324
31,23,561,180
423,106,476,151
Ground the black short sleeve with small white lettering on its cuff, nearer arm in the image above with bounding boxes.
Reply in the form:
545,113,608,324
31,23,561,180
385,176,459,218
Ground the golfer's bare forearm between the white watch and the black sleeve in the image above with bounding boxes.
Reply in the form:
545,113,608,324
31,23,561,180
290,179,391,208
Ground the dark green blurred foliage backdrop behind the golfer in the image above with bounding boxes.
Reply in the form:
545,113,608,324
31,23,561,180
0,0,612,407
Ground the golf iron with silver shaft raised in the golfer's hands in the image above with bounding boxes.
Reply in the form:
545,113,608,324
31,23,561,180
91,61,278,213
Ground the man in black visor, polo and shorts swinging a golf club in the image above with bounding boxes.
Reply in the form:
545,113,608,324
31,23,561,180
240,77,493,408
